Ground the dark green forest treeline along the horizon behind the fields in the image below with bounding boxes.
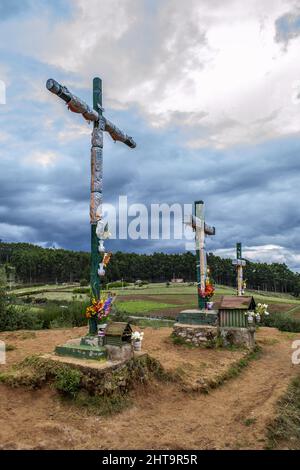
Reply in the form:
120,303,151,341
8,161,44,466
0,242,300,296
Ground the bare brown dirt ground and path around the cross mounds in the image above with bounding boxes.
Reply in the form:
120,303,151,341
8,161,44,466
0,328,300,449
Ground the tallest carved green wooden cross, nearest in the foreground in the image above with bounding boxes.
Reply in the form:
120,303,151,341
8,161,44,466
46,77,136,334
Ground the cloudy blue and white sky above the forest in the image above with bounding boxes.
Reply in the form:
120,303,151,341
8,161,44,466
0,0,300,270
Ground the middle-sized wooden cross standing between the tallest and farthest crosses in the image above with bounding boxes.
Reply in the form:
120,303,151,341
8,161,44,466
187,201,216,309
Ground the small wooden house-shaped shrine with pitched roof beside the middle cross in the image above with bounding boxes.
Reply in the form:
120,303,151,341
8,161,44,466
219,295,256,328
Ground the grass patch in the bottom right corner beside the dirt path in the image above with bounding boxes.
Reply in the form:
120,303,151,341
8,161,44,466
267,374,300,450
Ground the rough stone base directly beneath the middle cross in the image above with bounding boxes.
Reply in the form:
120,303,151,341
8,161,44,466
172,323,218,346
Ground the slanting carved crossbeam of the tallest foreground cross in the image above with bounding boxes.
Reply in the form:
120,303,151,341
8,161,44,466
46,78,136,148
